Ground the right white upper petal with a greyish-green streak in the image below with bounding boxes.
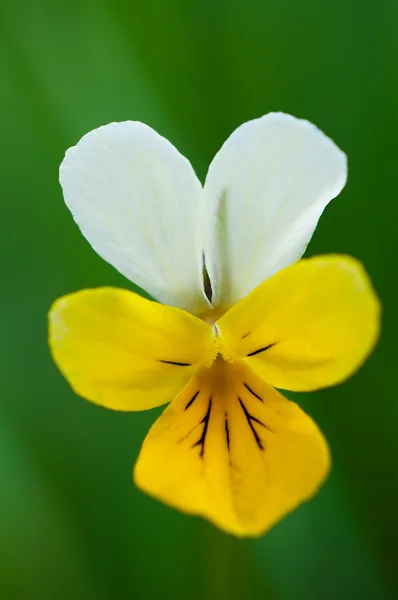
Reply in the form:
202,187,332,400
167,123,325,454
203,113,347,307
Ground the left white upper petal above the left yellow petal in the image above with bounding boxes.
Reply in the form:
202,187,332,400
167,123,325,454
60,121,208,313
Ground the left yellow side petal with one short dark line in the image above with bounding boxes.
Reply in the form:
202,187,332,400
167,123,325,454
49,288,213,410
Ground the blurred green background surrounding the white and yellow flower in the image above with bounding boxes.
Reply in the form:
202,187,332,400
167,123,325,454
0,0,398,600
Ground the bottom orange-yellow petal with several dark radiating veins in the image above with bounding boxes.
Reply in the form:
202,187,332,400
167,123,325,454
134,359,329,536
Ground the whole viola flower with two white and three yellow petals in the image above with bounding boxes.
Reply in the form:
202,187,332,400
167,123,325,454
49,113,380,536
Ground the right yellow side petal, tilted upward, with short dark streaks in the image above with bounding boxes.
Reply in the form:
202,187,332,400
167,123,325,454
217,255,380,391
